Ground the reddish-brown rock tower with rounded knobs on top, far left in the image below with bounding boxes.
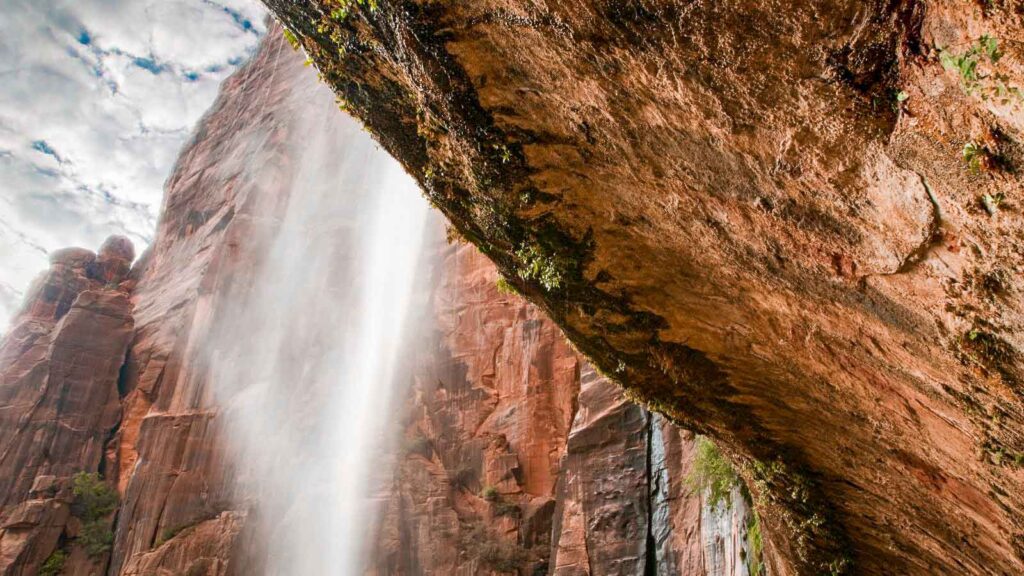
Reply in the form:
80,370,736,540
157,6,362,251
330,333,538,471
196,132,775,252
0,237,134,575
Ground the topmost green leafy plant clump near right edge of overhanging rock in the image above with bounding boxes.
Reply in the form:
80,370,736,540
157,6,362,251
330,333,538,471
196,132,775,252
939,35,1024,105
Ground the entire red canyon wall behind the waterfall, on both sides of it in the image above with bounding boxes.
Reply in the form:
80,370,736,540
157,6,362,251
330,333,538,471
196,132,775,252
0,24,757,576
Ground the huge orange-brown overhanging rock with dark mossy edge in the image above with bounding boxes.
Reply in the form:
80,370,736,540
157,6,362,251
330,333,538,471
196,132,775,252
265,0,1024,575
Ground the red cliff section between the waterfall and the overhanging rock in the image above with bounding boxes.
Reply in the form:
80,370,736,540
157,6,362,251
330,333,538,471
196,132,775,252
374,237,754,576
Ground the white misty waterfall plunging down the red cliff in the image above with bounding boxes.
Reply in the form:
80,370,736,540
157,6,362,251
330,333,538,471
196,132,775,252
203,48,428,576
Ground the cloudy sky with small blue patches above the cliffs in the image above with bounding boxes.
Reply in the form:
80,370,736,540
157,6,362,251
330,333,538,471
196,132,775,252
0,0,265,334
